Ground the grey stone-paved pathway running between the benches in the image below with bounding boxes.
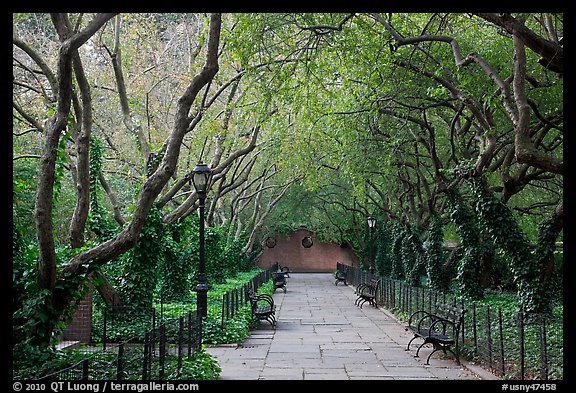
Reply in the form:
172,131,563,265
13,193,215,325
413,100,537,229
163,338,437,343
207,273,497,380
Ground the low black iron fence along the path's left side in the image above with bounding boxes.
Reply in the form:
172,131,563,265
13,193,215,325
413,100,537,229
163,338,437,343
40,265,278,380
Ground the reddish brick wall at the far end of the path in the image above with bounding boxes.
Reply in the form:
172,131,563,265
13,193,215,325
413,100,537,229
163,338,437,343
258,229,358,272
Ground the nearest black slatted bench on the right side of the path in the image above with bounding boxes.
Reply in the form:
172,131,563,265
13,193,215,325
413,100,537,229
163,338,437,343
406,302,465,364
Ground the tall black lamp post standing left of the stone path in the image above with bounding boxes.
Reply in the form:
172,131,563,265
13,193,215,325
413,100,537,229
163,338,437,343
192,164,212,348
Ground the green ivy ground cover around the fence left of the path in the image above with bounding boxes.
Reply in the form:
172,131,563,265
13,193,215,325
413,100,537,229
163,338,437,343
14,269,272,379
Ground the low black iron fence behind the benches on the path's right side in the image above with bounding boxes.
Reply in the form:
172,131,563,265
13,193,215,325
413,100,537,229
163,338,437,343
337,263,564,380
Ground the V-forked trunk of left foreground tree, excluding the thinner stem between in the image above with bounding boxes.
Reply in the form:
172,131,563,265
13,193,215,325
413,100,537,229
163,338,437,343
35,14,221,339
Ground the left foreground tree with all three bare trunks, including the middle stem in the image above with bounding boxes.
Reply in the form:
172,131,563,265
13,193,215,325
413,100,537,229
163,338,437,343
12,14,221,339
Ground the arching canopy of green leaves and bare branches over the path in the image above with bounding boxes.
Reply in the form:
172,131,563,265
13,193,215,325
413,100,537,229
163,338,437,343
13,13,563,342
